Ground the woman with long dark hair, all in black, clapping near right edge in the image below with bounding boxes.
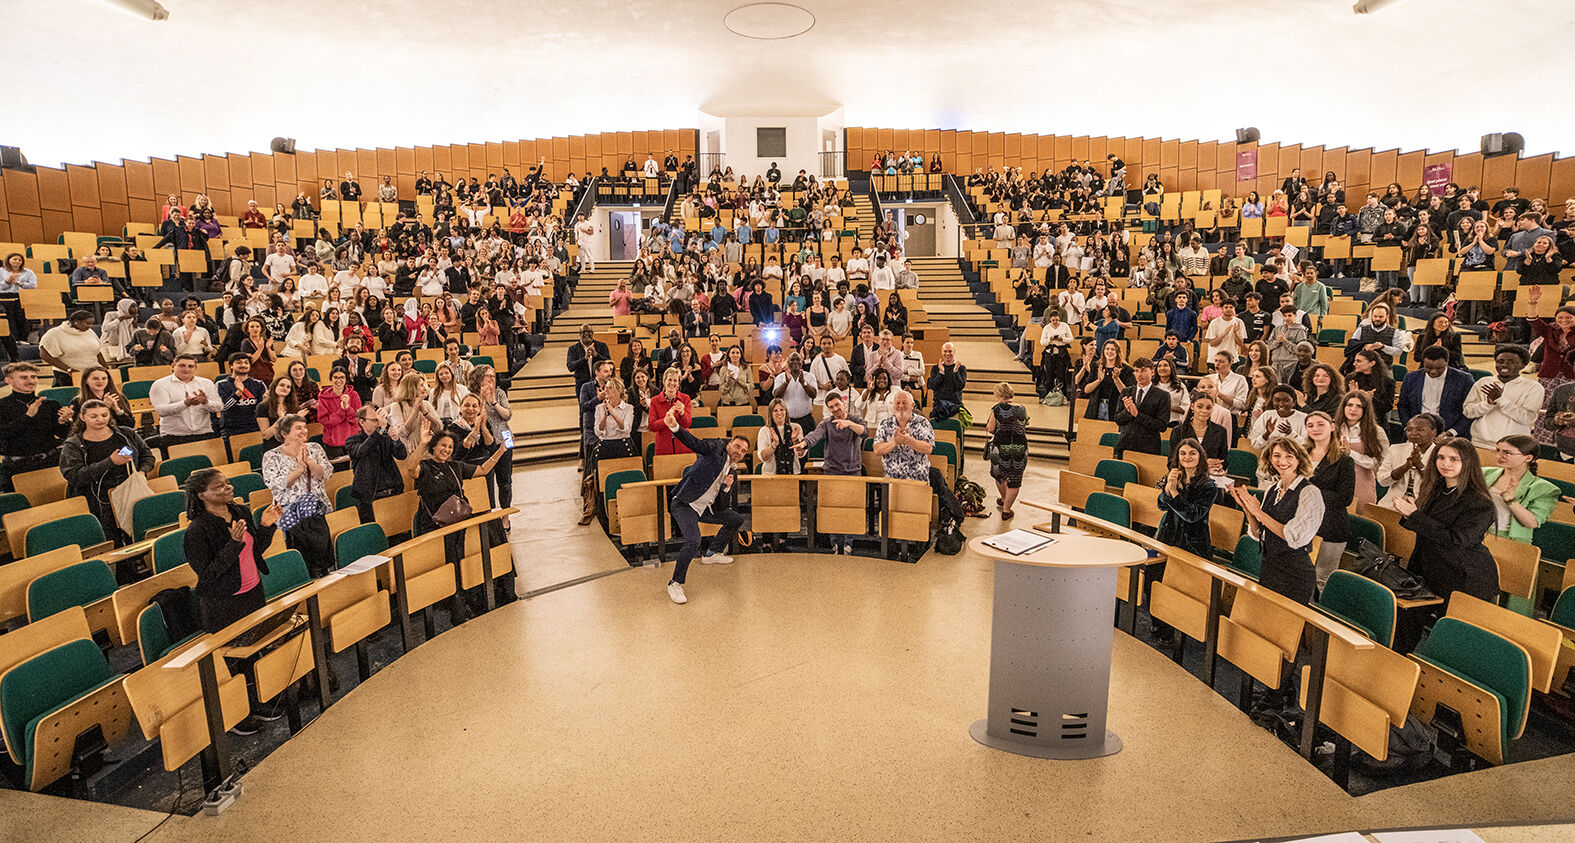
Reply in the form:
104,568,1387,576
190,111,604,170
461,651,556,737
1394,436,1498,605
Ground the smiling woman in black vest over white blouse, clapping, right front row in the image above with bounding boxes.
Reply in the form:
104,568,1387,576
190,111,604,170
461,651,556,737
1230,436,1323,603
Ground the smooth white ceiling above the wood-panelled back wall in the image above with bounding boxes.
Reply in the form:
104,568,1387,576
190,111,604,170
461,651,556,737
15,0,1575,170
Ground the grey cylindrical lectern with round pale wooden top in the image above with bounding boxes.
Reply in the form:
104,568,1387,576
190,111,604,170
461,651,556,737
969,533,1148,759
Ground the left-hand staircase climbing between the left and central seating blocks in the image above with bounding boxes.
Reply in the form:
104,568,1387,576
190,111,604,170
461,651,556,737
509,262,633,465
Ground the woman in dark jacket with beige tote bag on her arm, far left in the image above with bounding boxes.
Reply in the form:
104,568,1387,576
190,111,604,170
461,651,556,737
60,399,153,545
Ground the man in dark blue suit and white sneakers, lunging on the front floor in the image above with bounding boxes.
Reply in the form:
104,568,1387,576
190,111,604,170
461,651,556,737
663,408,750,603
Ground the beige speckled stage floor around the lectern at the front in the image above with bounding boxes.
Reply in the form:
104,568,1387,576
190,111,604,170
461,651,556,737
9,466,1575,841
